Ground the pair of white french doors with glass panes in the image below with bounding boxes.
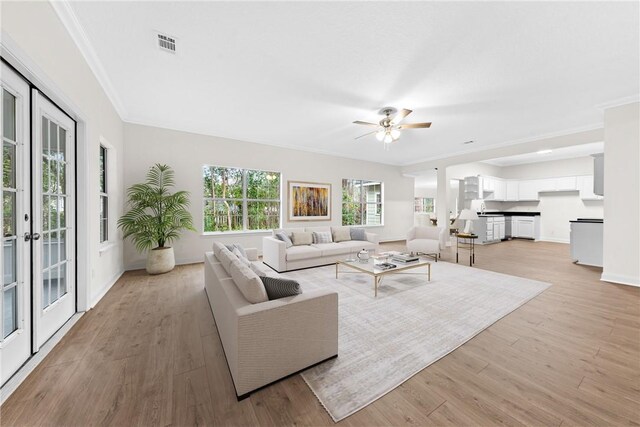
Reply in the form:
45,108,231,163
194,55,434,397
0,63,76,385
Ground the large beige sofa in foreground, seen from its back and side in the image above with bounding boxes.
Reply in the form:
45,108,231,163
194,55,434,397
204,246,338,400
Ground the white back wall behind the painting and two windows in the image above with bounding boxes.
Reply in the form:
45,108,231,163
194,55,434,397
124,124,414,269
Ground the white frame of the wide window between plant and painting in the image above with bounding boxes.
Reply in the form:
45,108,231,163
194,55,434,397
200,164,283,236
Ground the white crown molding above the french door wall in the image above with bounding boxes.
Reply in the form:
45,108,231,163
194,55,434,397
50,0,127,120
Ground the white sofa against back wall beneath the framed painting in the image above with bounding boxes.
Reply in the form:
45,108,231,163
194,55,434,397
262,227,379,272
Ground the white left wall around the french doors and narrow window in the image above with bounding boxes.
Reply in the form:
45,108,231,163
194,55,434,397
2,2,123,306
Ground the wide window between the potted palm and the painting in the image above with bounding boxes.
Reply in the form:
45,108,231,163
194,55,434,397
202,166,280,232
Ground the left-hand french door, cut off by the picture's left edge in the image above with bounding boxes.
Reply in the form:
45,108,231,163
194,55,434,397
0,64,31,385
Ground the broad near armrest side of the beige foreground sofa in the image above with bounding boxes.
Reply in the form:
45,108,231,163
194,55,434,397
236,290,338,395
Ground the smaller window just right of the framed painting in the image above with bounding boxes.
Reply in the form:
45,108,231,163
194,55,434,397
342,179,383,225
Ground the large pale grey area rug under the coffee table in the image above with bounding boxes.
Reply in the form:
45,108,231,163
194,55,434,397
283,262,550,422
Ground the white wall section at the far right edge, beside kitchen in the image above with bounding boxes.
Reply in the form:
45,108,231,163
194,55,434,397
602,102,640,286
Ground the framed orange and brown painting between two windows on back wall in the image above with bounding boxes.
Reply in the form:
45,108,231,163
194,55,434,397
287,181,331,221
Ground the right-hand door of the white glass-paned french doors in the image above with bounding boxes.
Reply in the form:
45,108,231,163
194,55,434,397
32,90,75,350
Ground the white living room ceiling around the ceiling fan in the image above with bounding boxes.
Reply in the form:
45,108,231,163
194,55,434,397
66,1,640,165
